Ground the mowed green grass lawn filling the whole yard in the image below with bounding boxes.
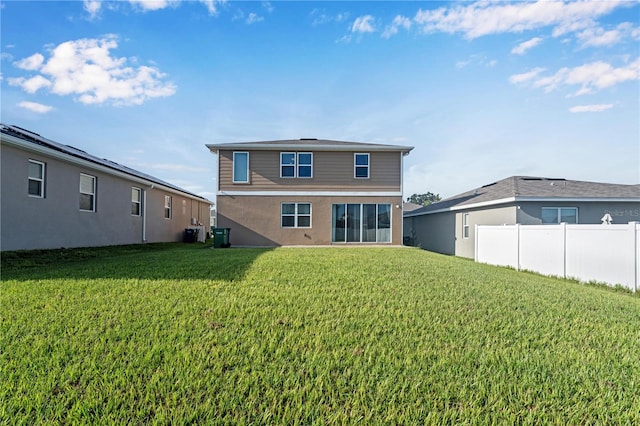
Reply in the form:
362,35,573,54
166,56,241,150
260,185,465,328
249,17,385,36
0,244,640,425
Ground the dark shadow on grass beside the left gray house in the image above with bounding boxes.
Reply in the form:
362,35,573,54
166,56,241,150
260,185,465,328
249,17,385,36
1,243,272,281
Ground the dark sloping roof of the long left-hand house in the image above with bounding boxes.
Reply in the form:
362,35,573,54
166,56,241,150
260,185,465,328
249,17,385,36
0,123,210,202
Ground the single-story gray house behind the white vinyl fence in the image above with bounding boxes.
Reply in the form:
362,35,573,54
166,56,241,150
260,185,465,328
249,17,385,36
404,176,640,258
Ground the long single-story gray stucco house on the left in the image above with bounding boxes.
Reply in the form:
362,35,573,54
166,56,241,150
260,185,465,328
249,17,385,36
0,125,212,251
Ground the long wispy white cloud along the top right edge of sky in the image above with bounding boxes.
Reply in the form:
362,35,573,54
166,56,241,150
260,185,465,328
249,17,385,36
414,0,633,39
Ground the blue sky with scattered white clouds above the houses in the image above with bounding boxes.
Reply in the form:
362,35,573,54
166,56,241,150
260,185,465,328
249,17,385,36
0,0,640,200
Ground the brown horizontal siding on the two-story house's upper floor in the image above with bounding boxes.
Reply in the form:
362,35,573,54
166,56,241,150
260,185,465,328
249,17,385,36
219,150,402,191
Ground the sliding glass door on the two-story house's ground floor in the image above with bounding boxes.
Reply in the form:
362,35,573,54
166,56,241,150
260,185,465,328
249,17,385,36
331,204,391,243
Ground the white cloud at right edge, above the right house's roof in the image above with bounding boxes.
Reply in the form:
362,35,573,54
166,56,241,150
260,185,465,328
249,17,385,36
509,58,640,96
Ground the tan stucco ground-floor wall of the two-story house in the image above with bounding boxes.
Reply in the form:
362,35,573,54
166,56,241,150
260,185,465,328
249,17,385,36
216,195,402,246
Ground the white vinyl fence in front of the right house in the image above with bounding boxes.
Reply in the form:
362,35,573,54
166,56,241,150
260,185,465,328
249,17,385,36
475,222,640,291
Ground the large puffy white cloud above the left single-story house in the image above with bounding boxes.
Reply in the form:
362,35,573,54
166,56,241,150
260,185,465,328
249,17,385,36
8,36,176,105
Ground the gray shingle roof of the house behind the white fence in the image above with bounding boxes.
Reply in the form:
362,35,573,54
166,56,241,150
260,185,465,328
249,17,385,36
405,176,640,216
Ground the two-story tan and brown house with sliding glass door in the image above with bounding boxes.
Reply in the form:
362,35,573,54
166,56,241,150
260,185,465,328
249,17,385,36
207,139,413,246
